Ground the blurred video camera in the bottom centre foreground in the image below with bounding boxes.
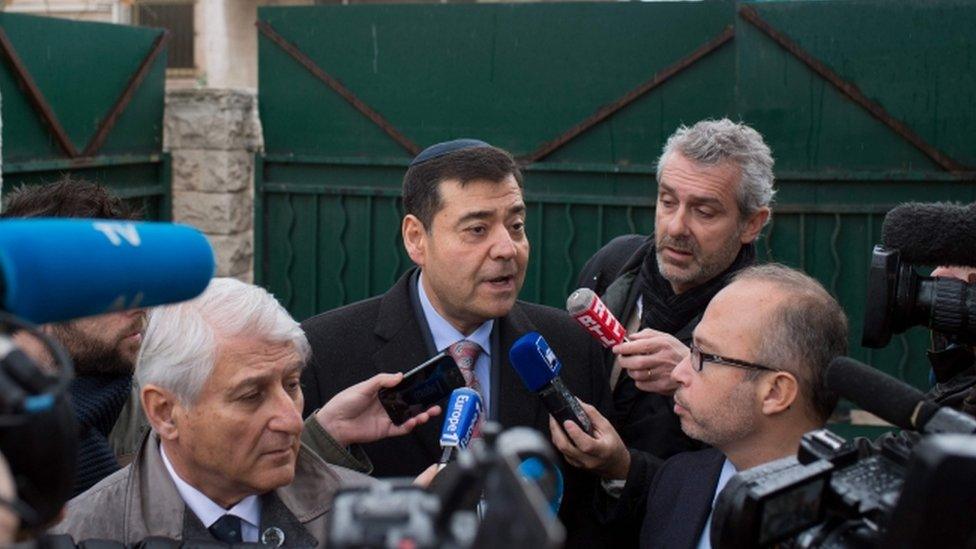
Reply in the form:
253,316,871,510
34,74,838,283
328,422,565,549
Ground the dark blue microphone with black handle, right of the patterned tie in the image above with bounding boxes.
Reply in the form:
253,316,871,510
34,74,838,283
508,332,593,434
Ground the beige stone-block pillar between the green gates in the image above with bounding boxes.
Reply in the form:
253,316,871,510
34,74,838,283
163,89,263,282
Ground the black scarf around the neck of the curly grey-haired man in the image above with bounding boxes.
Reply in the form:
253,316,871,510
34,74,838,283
640,243,756,334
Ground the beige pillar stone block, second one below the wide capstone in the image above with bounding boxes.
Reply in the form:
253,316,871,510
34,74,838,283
173,191,254,235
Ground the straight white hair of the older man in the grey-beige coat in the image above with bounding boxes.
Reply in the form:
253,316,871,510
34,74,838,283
135,278,311,406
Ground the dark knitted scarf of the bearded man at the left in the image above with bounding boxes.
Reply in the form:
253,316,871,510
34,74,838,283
68,374,132,495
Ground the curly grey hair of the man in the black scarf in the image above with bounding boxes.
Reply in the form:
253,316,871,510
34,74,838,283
657,118,776,221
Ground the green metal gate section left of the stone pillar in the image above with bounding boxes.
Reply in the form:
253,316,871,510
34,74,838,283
0,13,172,219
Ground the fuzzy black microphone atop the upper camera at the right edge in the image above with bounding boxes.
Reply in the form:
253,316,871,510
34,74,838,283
881,202,976,267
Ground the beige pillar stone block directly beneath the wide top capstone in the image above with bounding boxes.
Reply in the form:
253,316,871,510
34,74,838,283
172,149,254,193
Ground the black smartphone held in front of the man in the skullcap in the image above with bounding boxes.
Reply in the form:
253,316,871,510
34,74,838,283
379,353,465,425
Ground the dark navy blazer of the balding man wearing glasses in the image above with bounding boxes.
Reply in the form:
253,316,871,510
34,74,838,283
640,448,725,549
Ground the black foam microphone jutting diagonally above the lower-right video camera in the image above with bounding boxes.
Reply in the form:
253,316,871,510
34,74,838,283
827,356,976,434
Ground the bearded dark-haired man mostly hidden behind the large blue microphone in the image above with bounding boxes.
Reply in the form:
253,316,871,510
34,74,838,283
0,177,149,495
